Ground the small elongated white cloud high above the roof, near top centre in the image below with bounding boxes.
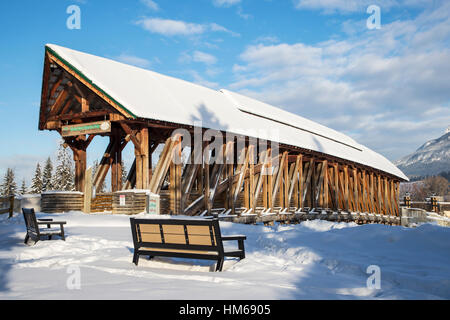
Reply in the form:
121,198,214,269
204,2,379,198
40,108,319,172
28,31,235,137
136,18,239,36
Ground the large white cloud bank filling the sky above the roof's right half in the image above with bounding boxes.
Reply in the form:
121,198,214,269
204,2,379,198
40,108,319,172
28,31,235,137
229,3,450,159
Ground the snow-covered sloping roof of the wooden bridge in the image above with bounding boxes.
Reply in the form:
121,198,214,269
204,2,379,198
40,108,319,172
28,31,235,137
46,44,408,180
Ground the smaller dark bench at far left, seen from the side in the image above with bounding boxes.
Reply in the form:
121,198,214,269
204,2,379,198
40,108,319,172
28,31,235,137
22,208,66,244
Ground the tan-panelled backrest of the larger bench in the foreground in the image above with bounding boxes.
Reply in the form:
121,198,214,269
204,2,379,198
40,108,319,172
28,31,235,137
130,218,223,253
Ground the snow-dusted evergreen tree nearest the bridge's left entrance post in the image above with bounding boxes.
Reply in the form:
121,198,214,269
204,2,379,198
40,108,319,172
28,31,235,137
52,142,75,191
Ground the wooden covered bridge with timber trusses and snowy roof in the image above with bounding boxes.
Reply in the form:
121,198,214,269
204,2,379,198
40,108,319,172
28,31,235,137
39,45,407,223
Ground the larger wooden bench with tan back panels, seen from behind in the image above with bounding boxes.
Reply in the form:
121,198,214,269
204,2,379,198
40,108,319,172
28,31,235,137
130,218,246,271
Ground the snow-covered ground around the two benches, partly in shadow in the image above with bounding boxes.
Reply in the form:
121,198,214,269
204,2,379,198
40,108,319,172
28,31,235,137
0,212,450,299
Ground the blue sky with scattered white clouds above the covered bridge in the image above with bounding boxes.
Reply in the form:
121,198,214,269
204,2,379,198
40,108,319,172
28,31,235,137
0,0,450,185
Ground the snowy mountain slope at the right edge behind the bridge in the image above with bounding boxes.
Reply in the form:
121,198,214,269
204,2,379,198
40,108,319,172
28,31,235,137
395,132,450,177
